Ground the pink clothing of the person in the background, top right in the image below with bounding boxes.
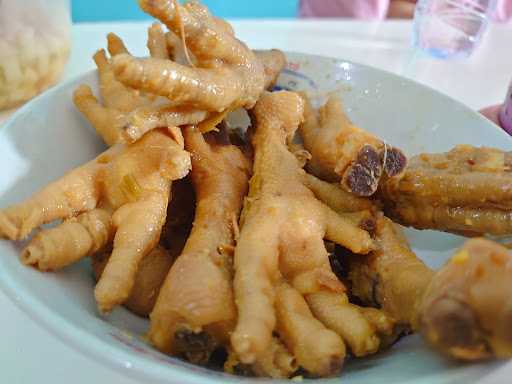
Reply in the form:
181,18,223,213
299,0,512,22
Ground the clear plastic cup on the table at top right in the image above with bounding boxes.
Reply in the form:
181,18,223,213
414,0,495,58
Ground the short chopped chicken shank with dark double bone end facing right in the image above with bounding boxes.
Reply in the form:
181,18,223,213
299,94,407,196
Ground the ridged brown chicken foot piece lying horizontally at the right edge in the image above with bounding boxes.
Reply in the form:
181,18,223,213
380,145,512,235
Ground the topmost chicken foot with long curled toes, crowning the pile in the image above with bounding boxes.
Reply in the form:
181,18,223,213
113,0,265,112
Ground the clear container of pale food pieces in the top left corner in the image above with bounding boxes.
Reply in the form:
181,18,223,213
0,0,71,110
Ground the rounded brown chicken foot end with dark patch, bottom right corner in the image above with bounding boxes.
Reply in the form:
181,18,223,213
419,239,512,360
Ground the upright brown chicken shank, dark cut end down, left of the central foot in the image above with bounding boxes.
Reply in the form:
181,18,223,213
149,127,249,354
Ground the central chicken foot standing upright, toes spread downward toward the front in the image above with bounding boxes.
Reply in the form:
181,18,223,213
231,92,374,376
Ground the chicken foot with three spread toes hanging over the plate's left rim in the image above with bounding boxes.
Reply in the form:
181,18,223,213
0,129,190,311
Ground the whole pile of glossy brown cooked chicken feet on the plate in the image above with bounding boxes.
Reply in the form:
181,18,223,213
0,0,512,378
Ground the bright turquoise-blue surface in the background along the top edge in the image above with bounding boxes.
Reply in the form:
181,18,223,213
71,0,299,22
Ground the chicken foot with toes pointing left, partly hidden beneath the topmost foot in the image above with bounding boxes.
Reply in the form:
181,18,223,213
73,27,286,145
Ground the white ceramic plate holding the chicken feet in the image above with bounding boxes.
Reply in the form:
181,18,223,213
0,54,512,384
